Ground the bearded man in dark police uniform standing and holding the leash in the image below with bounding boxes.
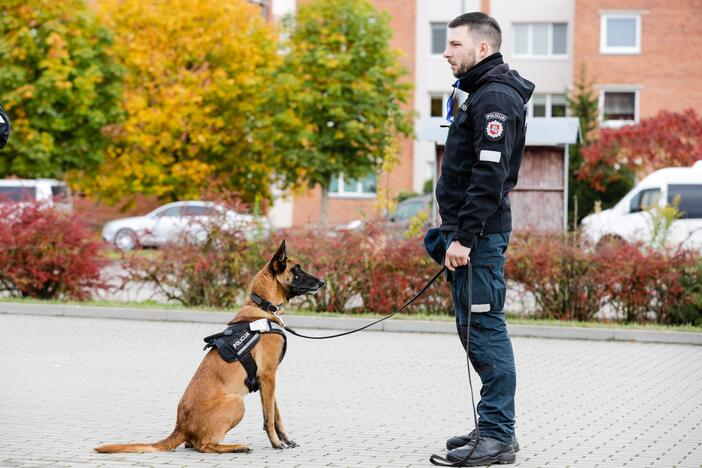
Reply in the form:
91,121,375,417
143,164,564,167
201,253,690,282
425,12,534,466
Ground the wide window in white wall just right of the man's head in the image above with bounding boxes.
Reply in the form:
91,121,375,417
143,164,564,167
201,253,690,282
512,23,568,58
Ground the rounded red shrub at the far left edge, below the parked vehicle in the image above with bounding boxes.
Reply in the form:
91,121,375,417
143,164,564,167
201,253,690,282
0,203,107,300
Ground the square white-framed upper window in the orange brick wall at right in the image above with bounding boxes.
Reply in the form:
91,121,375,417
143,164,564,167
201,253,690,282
600,13,641,54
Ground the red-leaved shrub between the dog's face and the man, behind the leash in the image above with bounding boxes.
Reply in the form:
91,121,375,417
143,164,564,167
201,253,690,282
278,223,451,313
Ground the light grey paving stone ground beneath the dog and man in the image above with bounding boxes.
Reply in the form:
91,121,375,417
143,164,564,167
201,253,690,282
0,315,702,467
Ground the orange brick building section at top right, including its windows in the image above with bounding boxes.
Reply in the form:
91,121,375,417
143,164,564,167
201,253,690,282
573,0,702,126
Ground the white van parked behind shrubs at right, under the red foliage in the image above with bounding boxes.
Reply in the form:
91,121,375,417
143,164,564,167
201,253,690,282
582,160,702,251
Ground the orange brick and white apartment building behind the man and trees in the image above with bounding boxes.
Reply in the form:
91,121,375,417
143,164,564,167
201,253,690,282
272,0,702,227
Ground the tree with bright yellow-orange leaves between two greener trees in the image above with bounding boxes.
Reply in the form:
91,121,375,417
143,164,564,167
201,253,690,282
78,0,280,205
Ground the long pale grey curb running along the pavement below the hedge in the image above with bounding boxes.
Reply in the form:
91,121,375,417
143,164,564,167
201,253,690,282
0,302,702,346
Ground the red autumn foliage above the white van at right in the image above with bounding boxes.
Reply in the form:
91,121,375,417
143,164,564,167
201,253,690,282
578,109,702,192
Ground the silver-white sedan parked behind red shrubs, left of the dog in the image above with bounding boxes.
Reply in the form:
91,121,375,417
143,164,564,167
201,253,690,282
102,201,270,250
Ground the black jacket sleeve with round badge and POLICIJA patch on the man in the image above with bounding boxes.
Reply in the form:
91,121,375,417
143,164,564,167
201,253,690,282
456,91,517,248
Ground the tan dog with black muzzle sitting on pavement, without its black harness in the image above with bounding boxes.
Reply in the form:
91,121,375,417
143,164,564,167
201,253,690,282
95,241,324,453
